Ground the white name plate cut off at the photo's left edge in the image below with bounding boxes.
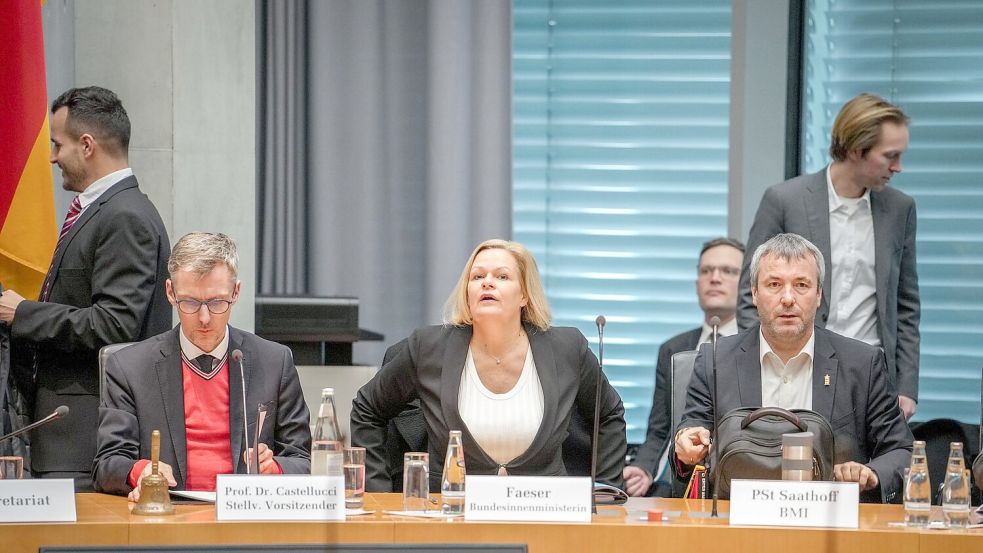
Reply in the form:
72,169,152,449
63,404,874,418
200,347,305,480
0,478,77,522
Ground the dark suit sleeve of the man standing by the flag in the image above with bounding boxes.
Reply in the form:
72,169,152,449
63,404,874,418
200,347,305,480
11,207,164,351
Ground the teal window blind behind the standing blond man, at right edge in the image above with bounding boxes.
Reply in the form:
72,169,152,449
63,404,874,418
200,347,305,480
802,0,983,423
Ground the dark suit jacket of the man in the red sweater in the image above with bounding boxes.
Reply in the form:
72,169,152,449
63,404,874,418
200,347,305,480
92,325,311,495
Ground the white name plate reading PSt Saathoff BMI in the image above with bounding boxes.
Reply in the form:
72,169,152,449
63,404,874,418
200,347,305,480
730,480,860,528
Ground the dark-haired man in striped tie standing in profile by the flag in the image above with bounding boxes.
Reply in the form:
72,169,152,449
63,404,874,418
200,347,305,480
0,86,171,491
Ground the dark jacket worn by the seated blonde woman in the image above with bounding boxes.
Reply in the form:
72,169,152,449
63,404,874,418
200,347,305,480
351,326,627,489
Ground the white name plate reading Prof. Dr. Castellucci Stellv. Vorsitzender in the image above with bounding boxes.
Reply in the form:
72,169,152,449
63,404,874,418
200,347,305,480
215,474,345,520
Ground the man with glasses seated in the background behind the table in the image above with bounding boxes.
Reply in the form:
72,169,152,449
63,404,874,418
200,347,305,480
624,238,744,497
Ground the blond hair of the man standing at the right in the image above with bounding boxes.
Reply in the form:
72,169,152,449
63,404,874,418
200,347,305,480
829,92,911,161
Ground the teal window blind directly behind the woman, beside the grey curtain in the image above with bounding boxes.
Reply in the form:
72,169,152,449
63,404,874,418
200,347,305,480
513,0,731,442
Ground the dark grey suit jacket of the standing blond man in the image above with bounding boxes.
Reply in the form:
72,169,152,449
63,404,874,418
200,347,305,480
737,169,921,400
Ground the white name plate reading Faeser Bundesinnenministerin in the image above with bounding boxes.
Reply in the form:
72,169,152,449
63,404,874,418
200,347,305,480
464,475,592,522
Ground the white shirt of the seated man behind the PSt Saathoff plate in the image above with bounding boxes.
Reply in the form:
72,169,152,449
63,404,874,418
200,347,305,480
758,328,816,409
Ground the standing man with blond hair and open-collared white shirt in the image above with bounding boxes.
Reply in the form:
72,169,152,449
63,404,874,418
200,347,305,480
738,94,921,418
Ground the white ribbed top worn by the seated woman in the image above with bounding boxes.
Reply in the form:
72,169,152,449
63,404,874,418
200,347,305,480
451,346,545,474
